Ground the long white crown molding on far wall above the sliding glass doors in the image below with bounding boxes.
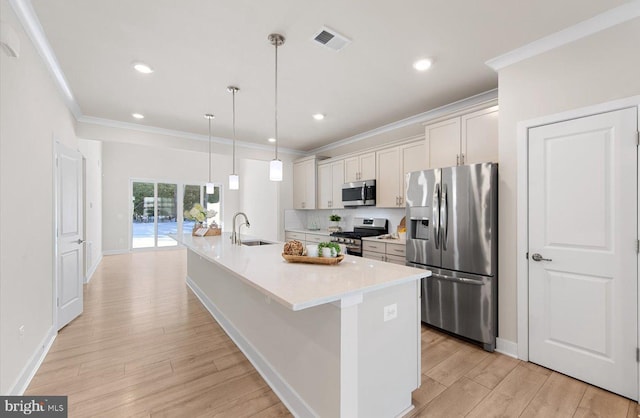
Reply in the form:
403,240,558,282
78,116,306,155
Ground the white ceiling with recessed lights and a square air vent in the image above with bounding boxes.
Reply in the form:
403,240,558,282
32,0,625,151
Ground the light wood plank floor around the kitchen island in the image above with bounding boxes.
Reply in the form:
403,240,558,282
26,250,640,418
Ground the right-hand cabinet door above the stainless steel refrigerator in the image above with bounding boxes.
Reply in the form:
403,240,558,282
462,106,498,164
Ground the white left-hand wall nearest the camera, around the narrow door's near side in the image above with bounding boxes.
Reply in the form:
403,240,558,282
0,1,78,394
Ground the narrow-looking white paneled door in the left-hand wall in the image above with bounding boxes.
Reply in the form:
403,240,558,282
56,144,84,329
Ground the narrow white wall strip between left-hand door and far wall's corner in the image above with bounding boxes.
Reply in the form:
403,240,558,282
78,139,102,281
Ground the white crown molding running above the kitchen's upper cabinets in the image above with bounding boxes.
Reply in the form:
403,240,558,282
307,89,498,155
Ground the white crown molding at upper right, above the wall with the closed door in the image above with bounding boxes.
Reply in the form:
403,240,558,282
485,0,640,71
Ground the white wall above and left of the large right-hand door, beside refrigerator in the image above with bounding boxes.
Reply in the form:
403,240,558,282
498,19,640,342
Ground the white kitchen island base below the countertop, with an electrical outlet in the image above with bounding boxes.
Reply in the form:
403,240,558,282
187,250,420,417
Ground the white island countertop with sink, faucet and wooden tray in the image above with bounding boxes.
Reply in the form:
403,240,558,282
174,233,431,311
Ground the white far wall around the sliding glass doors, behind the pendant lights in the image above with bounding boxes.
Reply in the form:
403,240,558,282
103,141,293,253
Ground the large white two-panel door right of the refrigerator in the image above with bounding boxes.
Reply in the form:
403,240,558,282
529,108,638,399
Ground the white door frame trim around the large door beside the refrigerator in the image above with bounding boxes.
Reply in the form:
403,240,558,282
516,96,640,399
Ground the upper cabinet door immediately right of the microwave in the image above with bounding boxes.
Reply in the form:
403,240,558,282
376,147,400,208
